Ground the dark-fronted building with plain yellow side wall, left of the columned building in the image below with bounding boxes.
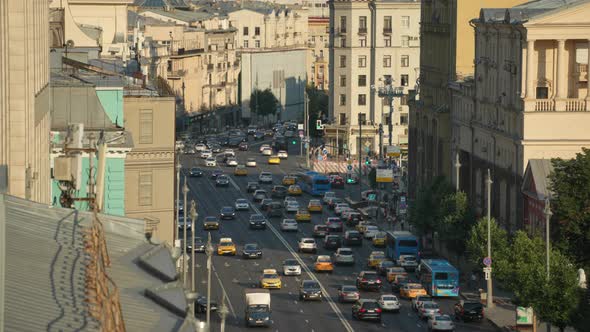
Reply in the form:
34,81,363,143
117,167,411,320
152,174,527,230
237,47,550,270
408,0,526,195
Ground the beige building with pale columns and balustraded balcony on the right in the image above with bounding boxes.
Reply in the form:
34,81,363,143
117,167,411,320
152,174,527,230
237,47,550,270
447,0,590,230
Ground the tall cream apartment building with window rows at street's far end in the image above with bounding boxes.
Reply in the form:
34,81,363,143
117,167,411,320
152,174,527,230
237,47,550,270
325,0,420,155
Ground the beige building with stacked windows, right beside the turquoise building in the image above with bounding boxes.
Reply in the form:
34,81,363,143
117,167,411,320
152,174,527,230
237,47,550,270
123,93,176,244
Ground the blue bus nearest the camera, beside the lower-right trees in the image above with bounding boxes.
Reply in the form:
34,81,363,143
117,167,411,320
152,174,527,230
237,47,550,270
419,259,459,297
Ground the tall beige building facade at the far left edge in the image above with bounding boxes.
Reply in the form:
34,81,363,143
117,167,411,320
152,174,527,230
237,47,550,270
0,0,51,203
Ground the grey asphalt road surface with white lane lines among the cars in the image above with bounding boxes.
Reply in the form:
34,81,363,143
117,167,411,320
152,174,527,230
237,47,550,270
181,137,495,332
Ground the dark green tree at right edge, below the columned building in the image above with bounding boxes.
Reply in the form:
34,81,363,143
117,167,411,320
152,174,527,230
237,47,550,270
549,148,590,269
